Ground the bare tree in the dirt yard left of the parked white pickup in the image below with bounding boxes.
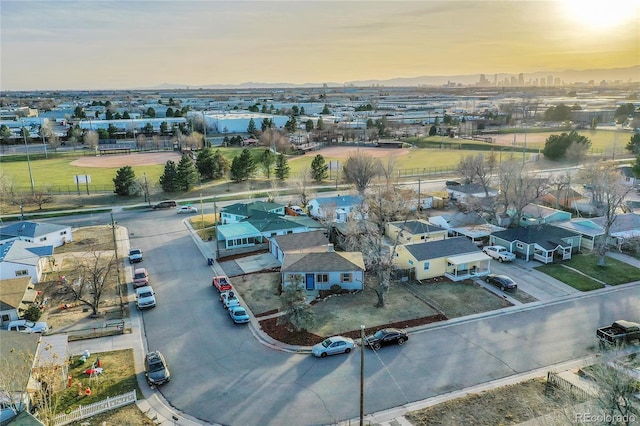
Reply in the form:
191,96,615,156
67,248,116,315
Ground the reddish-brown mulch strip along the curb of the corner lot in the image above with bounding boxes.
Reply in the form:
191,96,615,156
260,314,447,346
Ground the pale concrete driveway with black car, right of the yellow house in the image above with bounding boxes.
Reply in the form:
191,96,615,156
484,259,580,302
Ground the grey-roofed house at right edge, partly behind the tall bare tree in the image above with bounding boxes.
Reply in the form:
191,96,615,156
554,213,640,251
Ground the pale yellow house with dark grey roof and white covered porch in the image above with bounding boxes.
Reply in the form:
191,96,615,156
393,237,491,281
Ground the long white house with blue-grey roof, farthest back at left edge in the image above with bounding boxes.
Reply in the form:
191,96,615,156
0,221,73,247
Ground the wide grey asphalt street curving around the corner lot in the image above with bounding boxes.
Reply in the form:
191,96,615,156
48,210,640,425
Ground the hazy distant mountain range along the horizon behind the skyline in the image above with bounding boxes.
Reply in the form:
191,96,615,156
142,65,640,90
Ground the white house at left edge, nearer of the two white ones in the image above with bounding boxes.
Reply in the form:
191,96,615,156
0,240,53,283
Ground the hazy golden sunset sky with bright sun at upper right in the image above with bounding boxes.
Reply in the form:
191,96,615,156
0,0,640,90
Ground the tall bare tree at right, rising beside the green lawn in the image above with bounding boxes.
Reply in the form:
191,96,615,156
578,161,632,266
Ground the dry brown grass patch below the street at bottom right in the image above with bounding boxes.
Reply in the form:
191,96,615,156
405,378,568,426
